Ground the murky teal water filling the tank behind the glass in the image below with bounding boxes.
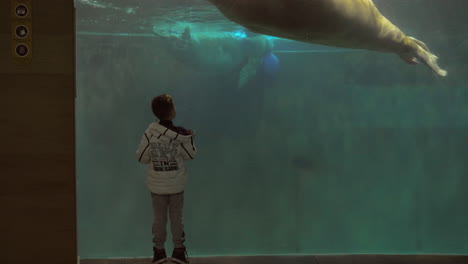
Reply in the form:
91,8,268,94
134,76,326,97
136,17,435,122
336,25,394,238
75,0,468,259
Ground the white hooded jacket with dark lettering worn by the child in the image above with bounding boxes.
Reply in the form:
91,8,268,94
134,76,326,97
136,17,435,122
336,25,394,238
136,123,197,194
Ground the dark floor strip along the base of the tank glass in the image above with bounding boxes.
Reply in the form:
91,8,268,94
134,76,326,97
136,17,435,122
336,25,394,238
80,255,468,264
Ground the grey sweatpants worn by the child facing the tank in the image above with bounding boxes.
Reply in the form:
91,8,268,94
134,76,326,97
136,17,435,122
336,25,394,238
151,192,185,249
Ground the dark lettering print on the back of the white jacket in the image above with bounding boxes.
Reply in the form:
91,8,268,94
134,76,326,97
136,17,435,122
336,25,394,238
151,142,180,171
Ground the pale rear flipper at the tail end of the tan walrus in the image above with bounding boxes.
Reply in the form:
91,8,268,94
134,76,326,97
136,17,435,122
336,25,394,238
400,37,447,77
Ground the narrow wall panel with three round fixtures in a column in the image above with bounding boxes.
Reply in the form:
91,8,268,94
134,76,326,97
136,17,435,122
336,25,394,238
10,0,33,63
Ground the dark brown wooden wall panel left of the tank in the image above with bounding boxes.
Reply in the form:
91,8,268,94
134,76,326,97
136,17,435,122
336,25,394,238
0,0,77,264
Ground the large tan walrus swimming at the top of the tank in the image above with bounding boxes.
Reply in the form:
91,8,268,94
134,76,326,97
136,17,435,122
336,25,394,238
208,0,447,76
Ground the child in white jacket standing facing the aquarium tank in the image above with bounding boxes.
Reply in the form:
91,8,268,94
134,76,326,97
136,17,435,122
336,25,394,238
136,94,197,264
